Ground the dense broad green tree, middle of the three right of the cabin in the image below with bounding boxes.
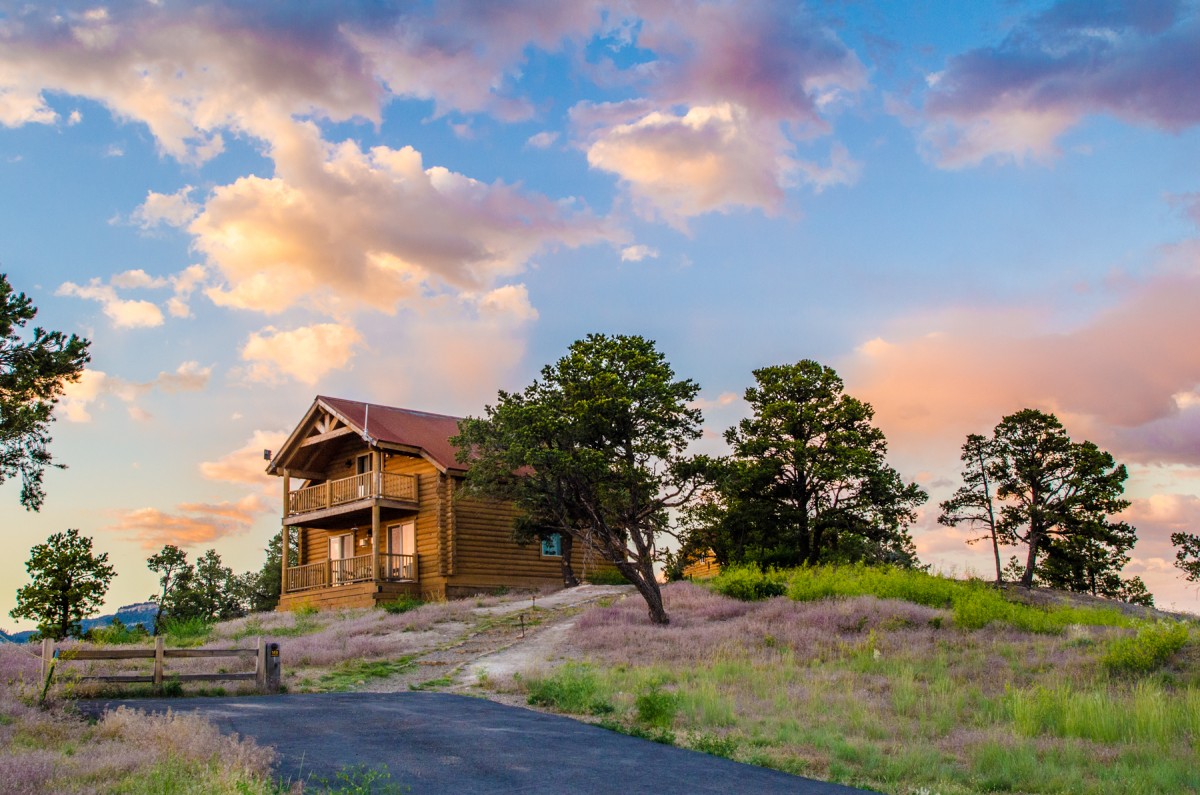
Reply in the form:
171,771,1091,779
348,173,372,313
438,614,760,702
685,359,928,574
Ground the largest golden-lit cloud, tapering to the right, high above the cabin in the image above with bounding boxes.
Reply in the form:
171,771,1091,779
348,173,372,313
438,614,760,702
188,124,619,315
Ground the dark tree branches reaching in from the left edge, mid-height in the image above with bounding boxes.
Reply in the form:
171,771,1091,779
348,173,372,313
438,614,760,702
0,274,91,510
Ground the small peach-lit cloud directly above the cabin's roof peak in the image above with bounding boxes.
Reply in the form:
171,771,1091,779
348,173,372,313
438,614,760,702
241,323,362,385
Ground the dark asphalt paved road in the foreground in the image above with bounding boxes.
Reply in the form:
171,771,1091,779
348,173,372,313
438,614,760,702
80,692,865,795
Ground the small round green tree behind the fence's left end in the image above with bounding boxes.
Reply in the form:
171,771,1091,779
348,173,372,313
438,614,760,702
10,528,116,640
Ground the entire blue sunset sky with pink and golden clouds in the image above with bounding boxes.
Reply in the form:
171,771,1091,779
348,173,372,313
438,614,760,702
0,0,1200,629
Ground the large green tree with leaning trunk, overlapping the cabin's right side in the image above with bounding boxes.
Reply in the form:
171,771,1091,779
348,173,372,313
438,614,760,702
452,334,701,623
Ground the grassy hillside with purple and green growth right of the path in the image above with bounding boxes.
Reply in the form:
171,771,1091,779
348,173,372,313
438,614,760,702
506,567,1200,795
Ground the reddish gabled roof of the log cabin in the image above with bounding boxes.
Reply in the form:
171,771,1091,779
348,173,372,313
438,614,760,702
268,395,467,474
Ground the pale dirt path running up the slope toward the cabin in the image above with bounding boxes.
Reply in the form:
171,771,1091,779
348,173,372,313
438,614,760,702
359,585,634,693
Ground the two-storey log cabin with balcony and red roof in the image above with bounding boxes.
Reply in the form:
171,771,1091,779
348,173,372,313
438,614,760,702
266,396,611,610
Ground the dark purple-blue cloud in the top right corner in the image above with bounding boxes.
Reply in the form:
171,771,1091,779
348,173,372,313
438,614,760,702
922,0,1200,168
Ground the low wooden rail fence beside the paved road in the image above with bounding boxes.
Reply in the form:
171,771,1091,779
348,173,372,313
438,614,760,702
42,636,281,693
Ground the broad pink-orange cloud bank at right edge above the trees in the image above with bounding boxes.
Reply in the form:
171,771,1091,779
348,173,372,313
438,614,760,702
841,243,1200,465
